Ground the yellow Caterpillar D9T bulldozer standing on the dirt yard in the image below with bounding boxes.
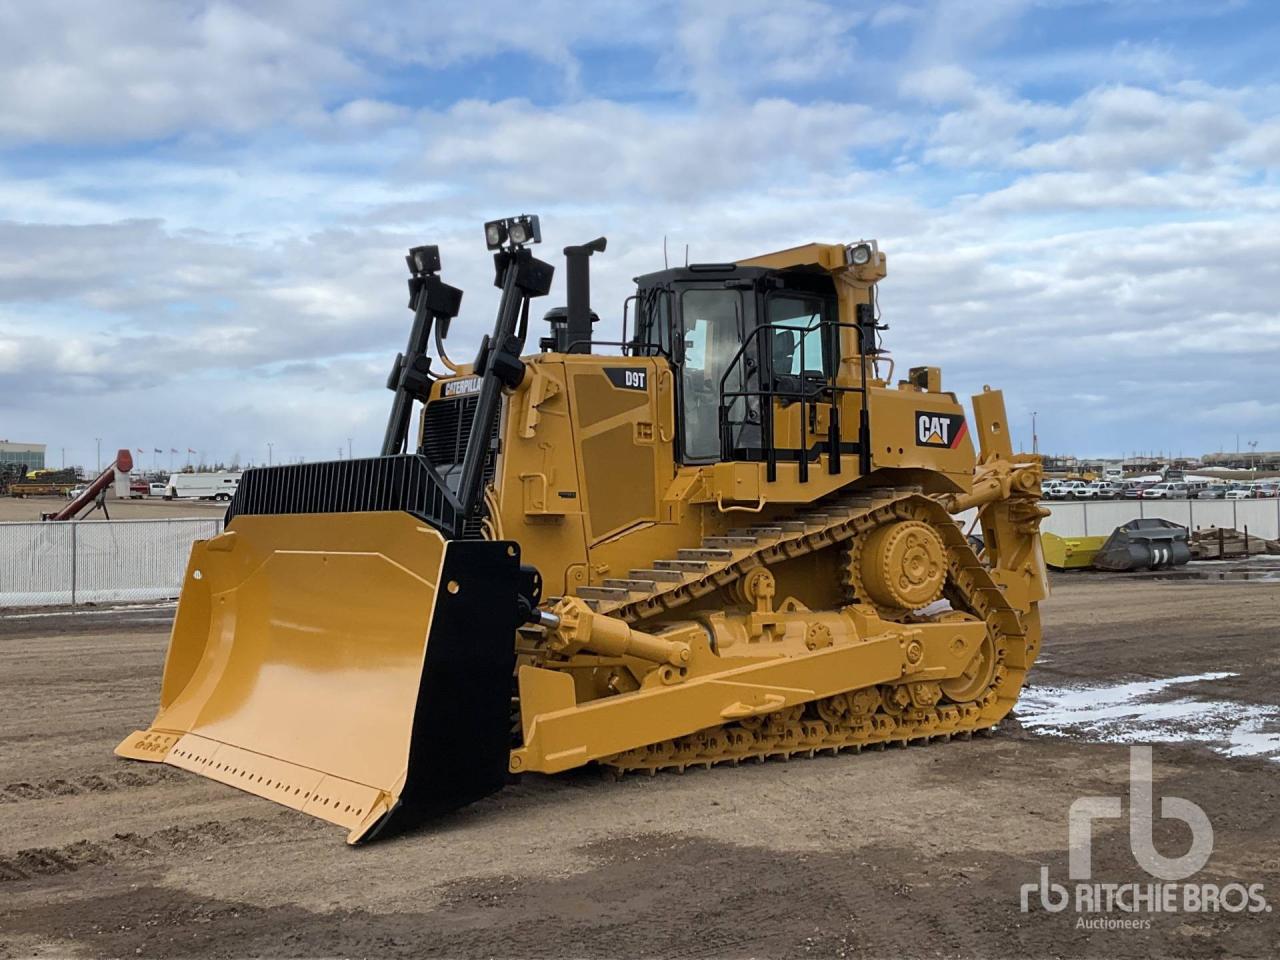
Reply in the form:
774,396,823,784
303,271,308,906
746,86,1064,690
116,216,1047,842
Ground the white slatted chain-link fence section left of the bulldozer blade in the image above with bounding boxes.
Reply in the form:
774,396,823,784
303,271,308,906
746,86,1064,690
0,517,223,607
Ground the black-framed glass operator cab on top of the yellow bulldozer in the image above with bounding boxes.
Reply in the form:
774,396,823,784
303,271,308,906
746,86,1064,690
627,264,840,463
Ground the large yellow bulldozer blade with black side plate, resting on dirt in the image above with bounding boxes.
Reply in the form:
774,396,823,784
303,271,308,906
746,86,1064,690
115,512,521,844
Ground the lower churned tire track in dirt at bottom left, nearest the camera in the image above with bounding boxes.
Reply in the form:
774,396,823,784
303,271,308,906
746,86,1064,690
0,817,279,883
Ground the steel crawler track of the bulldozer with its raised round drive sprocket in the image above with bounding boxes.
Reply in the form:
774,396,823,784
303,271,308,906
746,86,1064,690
585,489,1037,772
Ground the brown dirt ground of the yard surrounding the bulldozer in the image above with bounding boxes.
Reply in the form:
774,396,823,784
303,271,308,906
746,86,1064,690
0,575,1280,957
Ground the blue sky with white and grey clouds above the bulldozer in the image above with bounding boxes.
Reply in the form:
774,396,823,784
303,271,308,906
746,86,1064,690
0,0,1280,467
